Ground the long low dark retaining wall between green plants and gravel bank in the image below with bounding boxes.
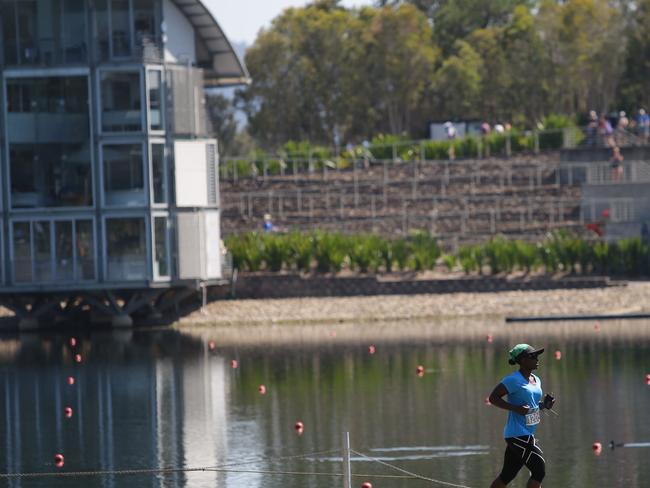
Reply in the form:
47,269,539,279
210,273,615,299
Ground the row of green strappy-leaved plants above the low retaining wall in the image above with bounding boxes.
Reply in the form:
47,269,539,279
226,231,650,276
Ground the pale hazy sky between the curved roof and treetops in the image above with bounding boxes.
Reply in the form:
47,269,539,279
203,0,372,44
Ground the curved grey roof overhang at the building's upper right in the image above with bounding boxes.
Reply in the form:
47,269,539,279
172,0,249,86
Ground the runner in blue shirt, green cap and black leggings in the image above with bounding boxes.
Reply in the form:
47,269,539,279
490,344,555,488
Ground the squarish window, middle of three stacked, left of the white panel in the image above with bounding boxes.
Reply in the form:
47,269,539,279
102,144,146,206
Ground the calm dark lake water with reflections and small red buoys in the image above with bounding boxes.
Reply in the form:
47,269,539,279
0,322,650,488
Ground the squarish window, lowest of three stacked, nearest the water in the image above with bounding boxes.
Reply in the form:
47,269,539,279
106,217,147,281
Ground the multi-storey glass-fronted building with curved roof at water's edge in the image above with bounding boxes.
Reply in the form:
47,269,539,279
0,0,247,327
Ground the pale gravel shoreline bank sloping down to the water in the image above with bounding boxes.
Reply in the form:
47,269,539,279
174,282,650,328
